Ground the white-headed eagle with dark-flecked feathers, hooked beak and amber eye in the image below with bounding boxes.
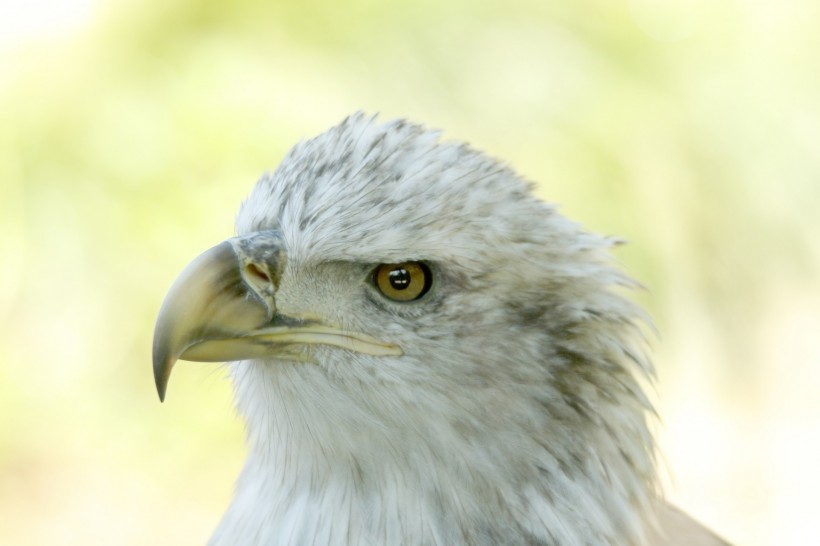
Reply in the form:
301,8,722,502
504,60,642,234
153,113,725,546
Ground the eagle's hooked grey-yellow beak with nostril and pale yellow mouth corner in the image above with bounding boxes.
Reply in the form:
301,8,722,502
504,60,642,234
153,231,402,400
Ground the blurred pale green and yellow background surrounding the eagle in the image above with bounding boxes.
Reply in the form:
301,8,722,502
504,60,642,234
0,0,820,546
